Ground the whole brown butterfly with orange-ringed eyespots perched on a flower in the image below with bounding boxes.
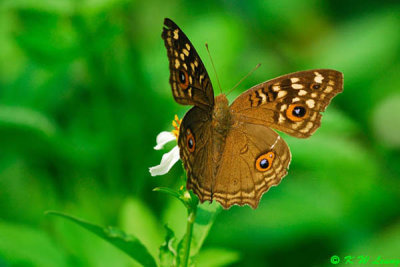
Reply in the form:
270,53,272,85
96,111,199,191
162,19,343,209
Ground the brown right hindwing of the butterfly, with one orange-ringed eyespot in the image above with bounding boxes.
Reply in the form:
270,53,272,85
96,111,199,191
212,123,291,209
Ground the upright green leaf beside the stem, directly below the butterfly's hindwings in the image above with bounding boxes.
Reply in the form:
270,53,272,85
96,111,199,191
190,201,222,256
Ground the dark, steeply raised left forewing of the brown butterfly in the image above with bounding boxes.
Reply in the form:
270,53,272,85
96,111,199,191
161,18,214,110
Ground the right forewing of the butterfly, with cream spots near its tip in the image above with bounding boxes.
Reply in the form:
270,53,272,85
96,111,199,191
230,69,343,138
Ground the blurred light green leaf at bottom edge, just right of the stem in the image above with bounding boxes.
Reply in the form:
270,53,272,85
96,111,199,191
194,248,240,267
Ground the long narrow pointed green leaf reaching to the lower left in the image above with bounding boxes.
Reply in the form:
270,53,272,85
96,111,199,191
46,211,157,266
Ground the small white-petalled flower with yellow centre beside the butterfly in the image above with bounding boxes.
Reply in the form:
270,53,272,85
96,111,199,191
149,115,181,176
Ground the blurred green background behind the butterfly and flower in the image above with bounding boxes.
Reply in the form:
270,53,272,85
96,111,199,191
0,0,400,266
